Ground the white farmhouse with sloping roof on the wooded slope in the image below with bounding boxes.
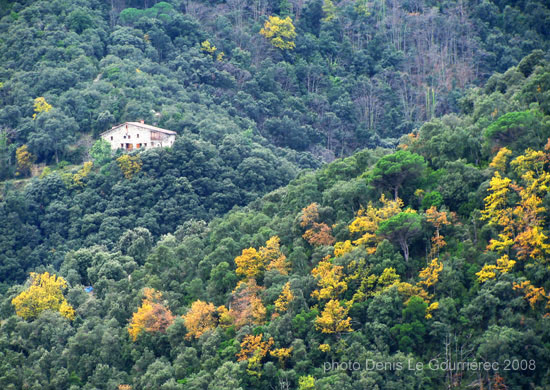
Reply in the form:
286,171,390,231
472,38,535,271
100,121,176,150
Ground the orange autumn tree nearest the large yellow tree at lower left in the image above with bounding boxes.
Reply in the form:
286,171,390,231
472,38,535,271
128,287,174,341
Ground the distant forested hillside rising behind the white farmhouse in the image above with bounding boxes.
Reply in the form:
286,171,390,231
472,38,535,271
0,0,550,172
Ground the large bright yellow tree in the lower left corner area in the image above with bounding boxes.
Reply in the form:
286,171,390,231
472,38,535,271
11,272,75,320
